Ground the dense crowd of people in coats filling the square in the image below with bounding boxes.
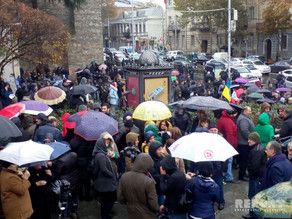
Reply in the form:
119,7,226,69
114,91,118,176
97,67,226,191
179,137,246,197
0,59,292,219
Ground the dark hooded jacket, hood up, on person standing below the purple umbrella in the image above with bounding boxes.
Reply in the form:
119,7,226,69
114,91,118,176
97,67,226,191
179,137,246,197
92,141,118,192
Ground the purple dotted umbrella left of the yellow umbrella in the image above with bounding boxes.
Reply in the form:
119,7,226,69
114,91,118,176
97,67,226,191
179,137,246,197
74,111,118,141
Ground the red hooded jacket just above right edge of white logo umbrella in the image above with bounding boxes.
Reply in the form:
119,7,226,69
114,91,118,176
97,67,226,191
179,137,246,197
217,110,237,148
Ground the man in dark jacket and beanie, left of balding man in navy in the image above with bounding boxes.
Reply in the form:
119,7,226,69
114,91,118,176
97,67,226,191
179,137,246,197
243,132,266,218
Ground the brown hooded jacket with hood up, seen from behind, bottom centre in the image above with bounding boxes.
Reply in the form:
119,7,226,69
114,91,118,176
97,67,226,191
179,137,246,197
118,153,159,219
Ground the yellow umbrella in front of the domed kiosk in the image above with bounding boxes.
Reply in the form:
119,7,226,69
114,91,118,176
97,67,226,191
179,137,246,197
133,101,172,121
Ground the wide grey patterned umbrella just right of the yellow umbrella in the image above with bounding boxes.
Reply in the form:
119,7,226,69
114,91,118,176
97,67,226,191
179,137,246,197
183,96,232,110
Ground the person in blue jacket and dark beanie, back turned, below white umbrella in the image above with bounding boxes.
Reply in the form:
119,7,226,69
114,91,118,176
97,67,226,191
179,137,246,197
186,162,219,219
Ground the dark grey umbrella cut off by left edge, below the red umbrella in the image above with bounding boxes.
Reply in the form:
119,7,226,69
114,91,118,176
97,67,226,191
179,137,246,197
0,116,22,146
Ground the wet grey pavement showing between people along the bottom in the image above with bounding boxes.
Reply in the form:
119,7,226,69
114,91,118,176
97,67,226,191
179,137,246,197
79,174,248,219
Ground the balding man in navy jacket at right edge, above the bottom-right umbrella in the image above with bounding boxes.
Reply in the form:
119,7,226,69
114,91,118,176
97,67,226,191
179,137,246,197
262,141,292,189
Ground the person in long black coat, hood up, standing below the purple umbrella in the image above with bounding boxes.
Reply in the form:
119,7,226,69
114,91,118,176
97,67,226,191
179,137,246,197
92,140,118,219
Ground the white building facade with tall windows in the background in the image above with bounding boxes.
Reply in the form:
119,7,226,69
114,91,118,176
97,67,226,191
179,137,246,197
107,7,164,51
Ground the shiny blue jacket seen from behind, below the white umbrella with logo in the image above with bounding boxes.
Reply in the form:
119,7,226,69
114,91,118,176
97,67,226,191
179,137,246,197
187,176,219,218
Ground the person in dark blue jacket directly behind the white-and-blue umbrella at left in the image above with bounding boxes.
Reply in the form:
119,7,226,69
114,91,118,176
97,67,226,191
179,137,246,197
33,113,62,143
